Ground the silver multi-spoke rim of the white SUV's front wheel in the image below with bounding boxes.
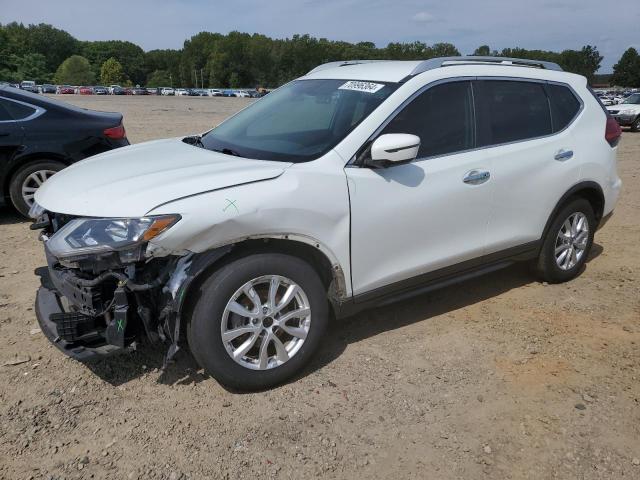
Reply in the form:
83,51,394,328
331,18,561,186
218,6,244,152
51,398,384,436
221,275,311,370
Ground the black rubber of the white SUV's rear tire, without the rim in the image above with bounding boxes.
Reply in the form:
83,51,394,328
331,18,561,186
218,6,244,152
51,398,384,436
535,198,597,283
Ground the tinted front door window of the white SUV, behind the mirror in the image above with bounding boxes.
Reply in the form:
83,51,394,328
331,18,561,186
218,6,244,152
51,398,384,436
382,82,474,158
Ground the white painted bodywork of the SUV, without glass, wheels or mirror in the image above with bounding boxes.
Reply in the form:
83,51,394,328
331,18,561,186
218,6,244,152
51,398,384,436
36,62,620,295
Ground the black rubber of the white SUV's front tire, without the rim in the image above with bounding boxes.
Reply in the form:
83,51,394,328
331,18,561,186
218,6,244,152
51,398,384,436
187,253,329,390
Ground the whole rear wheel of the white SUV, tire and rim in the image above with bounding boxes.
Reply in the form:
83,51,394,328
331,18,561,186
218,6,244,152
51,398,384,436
536,198,597,283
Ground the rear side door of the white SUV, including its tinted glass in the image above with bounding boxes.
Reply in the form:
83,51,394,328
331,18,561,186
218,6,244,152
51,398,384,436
474,79,581,254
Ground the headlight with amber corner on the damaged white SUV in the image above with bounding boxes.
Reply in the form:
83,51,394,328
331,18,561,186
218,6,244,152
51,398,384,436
47,215,180,261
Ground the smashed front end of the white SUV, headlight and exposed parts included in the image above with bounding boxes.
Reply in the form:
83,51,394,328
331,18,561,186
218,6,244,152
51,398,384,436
32,212,227,364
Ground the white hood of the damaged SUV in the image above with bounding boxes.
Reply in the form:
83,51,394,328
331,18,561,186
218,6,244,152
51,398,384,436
35,139,291,217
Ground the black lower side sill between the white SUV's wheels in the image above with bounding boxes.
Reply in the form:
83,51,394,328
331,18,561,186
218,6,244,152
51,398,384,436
334,240,541,318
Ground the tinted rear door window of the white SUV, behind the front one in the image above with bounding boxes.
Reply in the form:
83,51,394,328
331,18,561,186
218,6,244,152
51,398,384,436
474,80,552,146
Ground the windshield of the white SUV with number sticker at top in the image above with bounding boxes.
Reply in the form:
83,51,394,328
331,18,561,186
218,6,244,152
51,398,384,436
202,80,398,162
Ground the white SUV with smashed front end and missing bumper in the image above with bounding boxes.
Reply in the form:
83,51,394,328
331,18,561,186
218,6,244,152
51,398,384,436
32,57,621,389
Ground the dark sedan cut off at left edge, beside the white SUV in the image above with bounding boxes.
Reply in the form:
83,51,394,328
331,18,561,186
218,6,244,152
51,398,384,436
0,87,129,216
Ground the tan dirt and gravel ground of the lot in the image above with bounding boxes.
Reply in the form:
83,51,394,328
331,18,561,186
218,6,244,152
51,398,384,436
0,96,640,480
